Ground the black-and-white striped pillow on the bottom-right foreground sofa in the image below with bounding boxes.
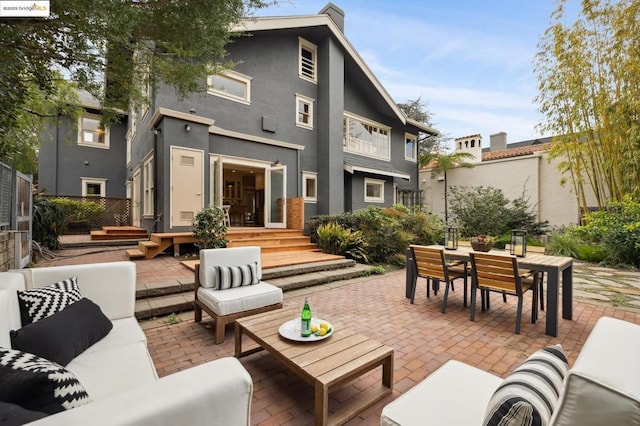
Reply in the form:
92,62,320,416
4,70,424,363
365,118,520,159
482,345,569,426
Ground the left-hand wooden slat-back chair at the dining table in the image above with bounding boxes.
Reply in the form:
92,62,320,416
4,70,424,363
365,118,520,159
409,244,469,314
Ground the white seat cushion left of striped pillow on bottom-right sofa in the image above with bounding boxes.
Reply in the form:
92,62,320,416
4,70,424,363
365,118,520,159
380,360,502,426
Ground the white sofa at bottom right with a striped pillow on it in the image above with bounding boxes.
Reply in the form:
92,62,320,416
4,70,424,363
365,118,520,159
380,317,640,426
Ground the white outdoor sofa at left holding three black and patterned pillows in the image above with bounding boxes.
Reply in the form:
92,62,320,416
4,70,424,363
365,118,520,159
0,262,253,426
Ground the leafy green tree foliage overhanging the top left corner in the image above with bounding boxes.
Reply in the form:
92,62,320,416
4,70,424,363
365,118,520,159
0,0,269,165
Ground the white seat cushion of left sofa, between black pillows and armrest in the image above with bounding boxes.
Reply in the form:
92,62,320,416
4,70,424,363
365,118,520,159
67,342,158,401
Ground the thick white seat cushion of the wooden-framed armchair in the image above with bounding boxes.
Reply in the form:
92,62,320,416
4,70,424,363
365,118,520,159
198,281,282,316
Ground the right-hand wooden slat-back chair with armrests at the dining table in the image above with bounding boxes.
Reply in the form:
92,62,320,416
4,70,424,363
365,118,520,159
470,252,538,334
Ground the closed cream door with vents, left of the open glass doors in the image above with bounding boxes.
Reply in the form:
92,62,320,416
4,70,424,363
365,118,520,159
169,146,204,228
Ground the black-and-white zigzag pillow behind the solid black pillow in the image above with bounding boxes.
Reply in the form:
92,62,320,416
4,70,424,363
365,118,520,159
18,277,82,327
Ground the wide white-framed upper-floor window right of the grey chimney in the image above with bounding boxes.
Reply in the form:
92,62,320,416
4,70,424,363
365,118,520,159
343,114,391,160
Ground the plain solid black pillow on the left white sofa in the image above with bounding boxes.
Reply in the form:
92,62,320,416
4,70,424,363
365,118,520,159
11,298,113,365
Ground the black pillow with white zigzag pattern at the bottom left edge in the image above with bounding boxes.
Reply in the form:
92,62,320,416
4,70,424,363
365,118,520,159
0,348,91,414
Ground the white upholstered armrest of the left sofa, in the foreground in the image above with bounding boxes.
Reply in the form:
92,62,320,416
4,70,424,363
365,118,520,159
33,358,253,426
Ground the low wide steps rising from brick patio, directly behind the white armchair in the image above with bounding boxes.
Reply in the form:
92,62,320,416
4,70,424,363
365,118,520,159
136,261,372,320
